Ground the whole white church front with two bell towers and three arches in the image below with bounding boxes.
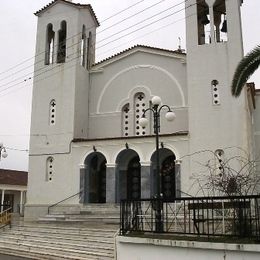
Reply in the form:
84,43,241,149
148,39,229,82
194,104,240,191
25,0,260,218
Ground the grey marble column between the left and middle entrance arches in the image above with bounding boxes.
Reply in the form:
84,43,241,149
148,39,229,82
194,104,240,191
106,163,116,203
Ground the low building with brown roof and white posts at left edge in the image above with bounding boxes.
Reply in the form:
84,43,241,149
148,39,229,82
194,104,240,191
0,169,28,214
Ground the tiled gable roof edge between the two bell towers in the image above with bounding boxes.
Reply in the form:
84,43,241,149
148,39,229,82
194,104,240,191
94,44,186,66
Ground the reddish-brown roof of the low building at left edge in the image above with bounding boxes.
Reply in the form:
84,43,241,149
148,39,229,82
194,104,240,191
0,169,28,186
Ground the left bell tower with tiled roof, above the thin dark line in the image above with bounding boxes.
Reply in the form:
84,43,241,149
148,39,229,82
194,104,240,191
31,0,99,154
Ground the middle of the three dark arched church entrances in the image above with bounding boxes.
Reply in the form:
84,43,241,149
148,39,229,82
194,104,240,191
116,149,141,202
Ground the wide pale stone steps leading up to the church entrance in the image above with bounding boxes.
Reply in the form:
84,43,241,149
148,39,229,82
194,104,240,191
0,207,119,260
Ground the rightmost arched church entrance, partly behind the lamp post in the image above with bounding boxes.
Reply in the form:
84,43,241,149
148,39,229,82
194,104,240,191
151,148,176,200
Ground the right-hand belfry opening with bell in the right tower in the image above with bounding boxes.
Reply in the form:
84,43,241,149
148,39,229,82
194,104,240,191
213,0,227,42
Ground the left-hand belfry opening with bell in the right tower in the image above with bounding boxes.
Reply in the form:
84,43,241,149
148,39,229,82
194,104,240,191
197,0,211,45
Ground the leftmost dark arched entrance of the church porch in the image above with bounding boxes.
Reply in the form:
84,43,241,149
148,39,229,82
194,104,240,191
84,152,107,203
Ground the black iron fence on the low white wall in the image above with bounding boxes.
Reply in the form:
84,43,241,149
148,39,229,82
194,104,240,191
120,195,260,240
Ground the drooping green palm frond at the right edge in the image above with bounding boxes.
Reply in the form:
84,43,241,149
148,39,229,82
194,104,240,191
231,45,260,97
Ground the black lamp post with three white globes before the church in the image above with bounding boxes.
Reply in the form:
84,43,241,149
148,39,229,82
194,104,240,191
139,96,176,233
